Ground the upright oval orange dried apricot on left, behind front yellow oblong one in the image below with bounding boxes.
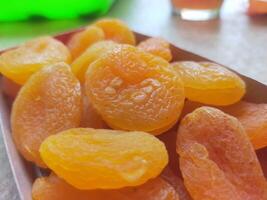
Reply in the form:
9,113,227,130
11,63,81,167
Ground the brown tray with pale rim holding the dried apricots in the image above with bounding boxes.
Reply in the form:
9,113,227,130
0,30,267,200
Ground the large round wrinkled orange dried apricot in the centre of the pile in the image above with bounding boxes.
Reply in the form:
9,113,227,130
85,45,184,134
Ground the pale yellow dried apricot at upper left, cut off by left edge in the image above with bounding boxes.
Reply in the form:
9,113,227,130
0,37,71,85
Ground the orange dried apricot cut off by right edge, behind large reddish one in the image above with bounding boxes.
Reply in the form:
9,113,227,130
221,101,267,149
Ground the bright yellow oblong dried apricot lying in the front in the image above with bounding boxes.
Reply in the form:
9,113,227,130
40,128,168,189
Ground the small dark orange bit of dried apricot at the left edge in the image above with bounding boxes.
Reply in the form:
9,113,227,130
1,77,20,99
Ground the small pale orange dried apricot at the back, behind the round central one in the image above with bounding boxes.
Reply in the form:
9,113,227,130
138,38,172,61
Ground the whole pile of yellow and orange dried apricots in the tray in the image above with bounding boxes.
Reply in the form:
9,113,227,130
0,19,267,200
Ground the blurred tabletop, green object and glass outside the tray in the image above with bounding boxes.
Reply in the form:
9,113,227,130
0,0,267,200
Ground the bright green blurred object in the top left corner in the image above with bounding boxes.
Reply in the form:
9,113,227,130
0,0,114,21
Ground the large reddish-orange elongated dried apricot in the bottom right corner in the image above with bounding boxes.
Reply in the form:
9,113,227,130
177,107,267,200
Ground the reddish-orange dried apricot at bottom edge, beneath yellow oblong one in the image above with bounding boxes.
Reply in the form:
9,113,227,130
32,174,179,200
